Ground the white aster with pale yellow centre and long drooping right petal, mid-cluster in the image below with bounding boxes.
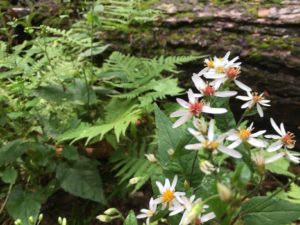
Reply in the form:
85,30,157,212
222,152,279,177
185,120,242,158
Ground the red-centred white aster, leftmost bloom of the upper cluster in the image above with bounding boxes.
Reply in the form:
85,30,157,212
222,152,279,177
170,89,227,128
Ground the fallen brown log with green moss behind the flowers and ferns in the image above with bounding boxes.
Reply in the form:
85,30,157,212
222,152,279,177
106,0,300,142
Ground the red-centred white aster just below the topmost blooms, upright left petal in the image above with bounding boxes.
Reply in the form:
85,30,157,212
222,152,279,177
192,74,237,97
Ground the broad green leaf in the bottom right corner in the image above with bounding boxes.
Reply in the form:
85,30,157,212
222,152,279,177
241,197,300,225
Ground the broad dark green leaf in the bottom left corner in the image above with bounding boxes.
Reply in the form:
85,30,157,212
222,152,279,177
6,186,43,225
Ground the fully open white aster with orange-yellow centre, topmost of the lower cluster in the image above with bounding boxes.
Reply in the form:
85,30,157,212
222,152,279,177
155,175,185,209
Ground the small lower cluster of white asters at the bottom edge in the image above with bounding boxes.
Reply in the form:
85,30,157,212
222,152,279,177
137,175,215,225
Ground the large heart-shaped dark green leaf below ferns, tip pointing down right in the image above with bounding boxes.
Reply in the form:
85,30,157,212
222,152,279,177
56,157,106,204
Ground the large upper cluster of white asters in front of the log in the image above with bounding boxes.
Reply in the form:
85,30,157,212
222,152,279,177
170,52,300,166
